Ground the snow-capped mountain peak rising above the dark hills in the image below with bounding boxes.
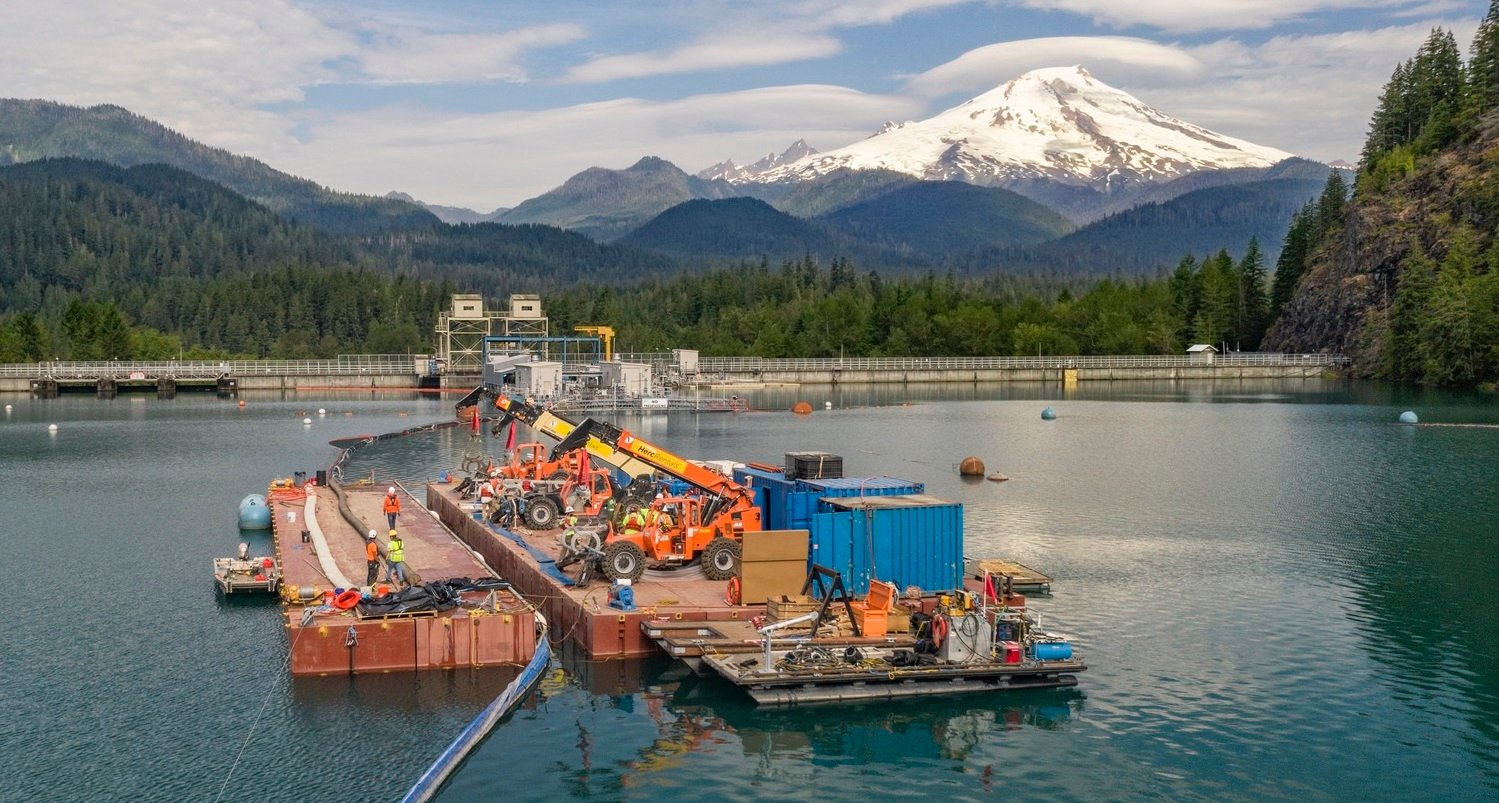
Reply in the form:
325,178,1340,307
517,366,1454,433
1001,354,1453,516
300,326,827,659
734,66,1292,193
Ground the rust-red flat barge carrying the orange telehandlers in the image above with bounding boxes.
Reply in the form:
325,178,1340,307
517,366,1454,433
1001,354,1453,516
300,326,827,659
427,482,764,658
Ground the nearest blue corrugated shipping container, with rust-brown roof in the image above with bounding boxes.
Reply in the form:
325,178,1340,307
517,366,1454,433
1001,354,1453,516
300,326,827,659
808,494,962,593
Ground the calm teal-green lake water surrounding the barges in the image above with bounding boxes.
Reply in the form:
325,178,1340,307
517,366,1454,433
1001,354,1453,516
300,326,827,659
0,382,1499,802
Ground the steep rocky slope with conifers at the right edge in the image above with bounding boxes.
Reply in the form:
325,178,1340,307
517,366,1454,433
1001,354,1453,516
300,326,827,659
1268,15,1499,385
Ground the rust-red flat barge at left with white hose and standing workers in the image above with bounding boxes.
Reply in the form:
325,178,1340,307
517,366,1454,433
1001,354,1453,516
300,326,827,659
267,485,537,676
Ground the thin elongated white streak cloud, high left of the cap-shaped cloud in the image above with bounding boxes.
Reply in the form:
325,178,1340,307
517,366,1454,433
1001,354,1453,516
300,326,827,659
562,30,841,84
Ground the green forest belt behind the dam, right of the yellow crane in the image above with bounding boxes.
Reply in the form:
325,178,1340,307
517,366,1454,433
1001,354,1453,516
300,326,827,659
546,246,1267,357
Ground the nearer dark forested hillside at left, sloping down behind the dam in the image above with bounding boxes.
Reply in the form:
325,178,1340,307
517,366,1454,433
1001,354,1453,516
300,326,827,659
0,159,453,361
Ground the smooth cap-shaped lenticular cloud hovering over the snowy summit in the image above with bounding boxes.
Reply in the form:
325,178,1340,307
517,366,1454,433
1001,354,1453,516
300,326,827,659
907,36,1204,96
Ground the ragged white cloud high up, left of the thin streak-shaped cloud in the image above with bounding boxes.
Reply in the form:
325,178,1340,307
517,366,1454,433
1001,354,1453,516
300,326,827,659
358,22,585,84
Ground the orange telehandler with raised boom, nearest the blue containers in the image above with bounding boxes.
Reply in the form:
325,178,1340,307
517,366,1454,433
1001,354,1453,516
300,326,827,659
552,418,760,580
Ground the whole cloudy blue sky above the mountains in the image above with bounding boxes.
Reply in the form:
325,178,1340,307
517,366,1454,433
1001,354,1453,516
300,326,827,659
0,0,1489,211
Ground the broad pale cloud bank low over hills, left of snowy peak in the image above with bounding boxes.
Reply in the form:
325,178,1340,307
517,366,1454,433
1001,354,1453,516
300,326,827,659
275,85,923,210
